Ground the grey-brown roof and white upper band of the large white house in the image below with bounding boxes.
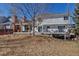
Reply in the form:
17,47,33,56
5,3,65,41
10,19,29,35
36,14,75,26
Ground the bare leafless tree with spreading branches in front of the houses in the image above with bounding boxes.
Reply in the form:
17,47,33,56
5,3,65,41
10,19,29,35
11,3,47,36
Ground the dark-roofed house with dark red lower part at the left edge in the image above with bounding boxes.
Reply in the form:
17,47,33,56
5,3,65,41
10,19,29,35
0,16,12,35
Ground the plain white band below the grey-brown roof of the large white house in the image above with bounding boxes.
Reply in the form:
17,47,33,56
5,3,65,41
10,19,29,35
39,18,69,26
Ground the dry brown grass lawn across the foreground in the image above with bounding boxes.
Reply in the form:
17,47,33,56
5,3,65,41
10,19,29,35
0,35,79,56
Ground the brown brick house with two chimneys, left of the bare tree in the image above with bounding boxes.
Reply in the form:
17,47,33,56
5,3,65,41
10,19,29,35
11,16,32,32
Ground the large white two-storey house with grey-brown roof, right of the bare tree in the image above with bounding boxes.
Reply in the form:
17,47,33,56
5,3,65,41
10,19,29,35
35,14,75,34
